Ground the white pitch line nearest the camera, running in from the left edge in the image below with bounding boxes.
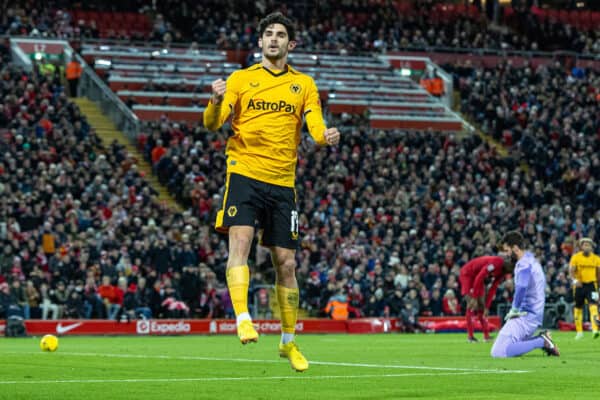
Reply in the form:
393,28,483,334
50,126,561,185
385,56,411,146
0,370,520,385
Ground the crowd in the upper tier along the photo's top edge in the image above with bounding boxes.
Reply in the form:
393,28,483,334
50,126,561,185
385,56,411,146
0,0,600,54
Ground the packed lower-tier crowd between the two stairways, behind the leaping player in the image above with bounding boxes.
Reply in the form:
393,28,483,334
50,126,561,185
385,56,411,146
138,83,600,324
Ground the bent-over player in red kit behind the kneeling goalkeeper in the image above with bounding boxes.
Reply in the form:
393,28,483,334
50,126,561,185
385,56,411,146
459,256,514,342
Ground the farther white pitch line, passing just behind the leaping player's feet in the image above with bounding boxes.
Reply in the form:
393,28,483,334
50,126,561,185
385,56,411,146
11,352,531,374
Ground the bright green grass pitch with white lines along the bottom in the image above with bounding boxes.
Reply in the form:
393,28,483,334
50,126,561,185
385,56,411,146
0,332,600,400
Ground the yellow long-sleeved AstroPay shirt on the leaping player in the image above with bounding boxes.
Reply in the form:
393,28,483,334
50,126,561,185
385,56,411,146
203,64,326,187
